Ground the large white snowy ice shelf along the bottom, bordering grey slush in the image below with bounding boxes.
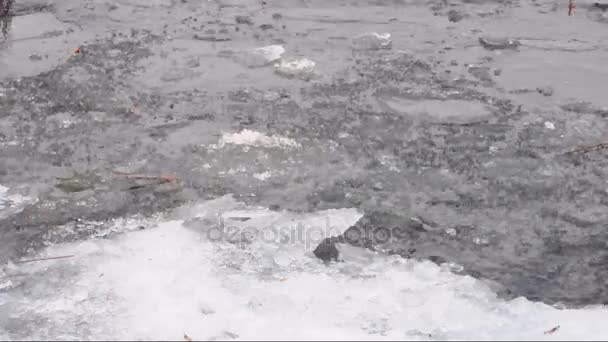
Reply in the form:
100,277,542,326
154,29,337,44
0,197,608,340
